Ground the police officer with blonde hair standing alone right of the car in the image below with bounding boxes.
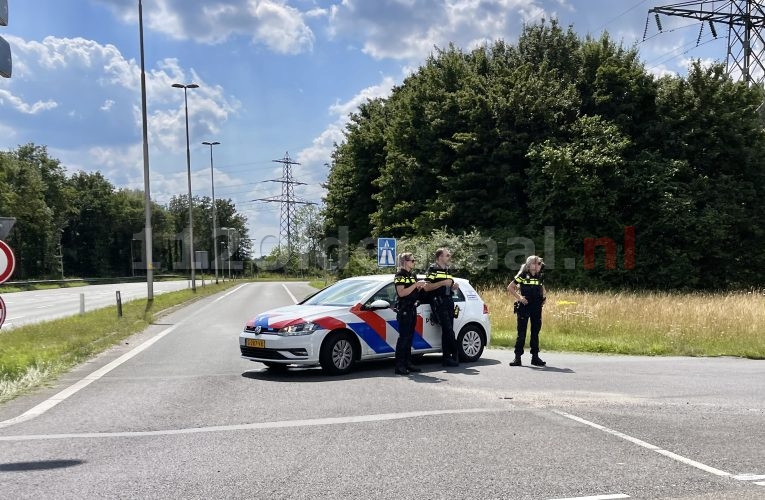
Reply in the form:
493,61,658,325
507,255,547,366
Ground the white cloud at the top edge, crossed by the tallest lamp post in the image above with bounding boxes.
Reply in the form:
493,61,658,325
97,0,316,54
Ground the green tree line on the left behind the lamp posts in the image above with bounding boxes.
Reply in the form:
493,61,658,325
0,144,250,280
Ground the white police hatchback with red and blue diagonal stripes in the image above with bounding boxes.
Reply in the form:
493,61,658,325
239,274,491,374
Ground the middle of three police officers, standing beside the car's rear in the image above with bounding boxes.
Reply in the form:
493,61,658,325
425,248,460,366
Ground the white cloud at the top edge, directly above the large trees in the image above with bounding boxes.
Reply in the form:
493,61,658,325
330,0,551,60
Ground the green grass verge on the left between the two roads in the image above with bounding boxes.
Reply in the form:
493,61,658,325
0,281,242,402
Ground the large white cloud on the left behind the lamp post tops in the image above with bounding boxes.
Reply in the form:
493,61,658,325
0,36,241,156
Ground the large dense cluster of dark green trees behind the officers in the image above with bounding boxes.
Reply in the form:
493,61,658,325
324,22,765,289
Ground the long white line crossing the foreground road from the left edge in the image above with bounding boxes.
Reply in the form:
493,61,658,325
0,408,509,441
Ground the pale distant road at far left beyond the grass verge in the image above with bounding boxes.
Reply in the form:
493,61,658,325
0,280,209,331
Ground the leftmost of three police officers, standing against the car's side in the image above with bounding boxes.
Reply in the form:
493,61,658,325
393,252,425,375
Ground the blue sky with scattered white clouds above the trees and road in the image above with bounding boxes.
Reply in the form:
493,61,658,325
0,0,727,255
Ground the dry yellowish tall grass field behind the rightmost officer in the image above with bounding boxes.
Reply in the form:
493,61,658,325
481,288,765,359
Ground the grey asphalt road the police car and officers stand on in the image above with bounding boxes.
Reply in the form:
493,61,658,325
0,283,765,500
